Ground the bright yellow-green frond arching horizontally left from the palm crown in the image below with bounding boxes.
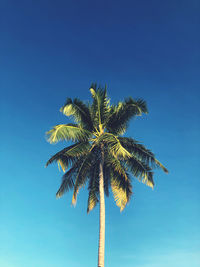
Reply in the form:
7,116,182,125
46,123,92,144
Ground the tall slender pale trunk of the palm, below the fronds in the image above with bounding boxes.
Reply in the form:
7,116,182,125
98,152,105,267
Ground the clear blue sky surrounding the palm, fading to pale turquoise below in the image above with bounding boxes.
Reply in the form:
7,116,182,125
0,0,200,267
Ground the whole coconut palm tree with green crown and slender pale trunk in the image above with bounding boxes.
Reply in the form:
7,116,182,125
46,84,168,267
